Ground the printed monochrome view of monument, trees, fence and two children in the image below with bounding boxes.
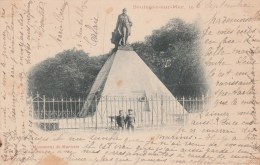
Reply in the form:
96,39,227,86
28,8,209,131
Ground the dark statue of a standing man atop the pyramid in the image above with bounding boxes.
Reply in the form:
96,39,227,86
111,8,132,47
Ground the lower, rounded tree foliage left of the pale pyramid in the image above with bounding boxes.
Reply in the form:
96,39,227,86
28,49,108,98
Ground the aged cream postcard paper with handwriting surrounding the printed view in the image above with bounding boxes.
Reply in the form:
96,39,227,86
0,0,260,165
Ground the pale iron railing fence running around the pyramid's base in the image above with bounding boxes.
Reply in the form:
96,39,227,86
32,94,209,131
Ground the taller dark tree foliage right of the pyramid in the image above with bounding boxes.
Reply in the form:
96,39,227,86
132,19,207,97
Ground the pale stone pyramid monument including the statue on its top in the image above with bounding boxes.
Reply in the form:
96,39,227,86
79,9,187,126
